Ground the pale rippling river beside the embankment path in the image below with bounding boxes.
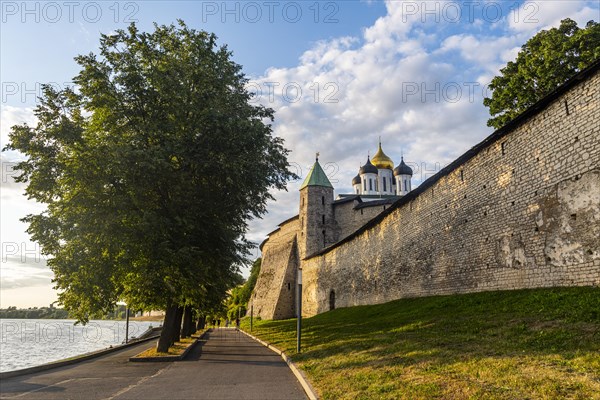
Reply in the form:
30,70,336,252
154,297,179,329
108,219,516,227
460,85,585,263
0,319,160,372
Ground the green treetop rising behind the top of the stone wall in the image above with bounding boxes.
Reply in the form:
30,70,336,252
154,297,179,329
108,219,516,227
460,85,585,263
483,18,600,129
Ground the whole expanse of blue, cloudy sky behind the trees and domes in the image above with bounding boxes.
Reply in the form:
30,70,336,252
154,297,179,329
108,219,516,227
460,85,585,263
0,0,600,308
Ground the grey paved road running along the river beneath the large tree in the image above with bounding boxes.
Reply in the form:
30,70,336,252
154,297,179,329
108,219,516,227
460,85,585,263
0,329,306,400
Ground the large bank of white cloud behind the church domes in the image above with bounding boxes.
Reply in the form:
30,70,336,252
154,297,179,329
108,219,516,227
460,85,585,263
244,1,598,250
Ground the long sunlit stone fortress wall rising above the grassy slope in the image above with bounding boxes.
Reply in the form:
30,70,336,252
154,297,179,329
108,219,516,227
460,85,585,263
302,65,600,316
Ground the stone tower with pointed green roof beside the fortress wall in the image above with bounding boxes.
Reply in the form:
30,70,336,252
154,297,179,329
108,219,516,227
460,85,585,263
298,153,336,259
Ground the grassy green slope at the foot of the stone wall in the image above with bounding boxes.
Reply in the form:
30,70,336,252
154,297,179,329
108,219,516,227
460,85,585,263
242,288,600,399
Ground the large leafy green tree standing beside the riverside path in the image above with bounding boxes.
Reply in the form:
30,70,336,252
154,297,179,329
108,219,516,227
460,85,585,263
5,21,293,351
